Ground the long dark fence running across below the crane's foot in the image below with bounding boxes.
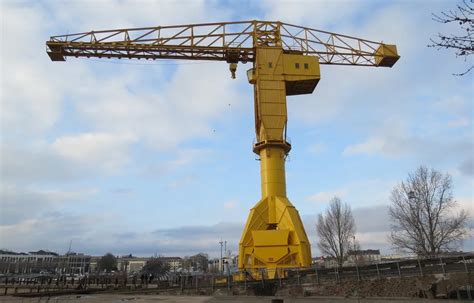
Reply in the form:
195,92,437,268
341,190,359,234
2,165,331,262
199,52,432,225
0,254,474,295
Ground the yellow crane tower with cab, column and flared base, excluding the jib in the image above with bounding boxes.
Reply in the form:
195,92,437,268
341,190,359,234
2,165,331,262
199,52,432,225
239,47,319,279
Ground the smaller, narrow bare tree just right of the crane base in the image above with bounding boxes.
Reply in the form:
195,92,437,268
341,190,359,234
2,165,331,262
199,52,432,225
316,197,355,265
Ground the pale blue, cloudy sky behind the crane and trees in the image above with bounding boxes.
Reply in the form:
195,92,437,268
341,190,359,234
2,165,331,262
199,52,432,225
0,0,474,256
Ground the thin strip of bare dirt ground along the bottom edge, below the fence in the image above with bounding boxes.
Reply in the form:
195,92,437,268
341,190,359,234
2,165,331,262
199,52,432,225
0,294,459,303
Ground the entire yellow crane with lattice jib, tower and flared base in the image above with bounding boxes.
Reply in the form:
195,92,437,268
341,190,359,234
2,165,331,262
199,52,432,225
46,20,399,279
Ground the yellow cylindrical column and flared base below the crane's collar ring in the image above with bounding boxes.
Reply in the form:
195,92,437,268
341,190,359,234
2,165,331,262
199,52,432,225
239,147,311,279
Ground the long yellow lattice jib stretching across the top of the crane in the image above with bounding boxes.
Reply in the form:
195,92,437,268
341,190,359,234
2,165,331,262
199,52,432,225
46,20,399,67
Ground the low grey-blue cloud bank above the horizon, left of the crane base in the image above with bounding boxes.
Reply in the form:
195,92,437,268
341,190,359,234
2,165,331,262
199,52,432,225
0,220,243,256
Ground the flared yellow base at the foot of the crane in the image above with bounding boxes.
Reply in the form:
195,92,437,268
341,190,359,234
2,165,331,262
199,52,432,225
239,196,311,280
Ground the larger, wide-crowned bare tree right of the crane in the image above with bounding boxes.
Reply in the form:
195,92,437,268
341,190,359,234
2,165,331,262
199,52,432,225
389,166,468,256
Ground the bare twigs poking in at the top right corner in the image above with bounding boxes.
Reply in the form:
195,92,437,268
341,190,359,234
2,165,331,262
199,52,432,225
428,0,474,76
